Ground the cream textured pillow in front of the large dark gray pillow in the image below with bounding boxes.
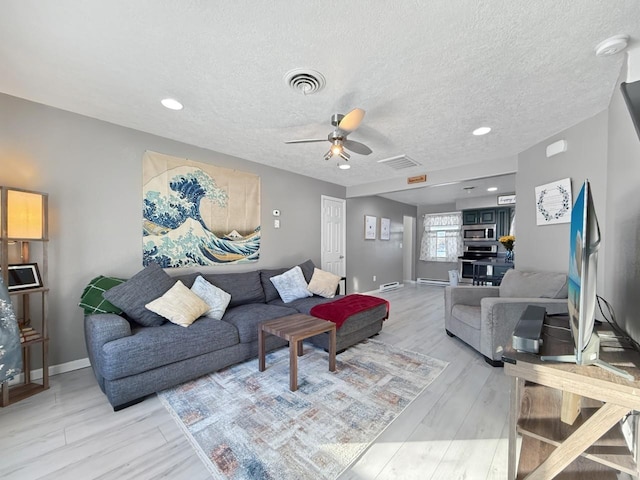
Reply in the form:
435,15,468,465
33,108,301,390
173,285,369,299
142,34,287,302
145,280,209,327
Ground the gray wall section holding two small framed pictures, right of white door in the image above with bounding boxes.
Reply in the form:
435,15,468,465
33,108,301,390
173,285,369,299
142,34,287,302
347,197,417,293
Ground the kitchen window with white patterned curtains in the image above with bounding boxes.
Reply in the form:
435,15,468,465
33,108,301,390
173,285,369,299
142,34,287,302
420,212,462,262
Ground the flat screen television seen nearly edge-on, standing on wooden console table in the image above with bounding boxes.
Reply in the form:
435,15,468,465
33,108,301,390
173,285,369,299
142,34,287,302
541,180,634,380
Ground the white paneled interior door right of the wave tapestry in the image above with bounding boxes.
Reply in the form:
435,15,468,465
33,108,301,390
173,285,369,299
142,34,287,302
320,195,347,277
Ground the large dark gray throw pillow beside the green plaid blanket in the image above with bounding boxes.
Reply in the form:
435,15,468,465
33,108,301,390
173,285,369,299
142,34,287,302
103,263,175,327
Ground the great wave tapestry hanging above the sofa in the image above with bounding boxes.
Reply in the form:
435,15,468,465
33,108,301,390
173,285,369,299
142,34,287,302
142,152,260,268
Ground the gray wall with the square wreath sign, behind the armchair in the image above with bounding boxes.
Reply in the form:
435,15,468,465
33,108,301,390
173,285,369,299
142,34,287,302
514,111,608,283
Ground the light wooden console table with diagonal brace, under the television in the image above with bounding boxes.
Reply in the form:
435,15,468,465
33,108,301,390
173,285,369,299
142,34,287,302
504,317,640,480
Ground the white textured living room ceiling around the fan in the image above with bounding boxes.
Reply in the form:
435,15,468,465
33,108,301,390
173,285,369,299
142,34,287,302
0,0,640,203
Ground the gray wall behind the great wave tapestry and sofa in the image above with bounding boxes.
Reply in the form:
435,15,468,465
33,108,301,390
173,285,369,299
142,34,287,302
0,95,344,365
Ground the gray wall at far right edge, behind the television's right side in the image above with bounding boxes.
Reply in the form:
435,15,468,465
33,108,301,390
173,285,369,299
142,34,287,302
596,72,640,341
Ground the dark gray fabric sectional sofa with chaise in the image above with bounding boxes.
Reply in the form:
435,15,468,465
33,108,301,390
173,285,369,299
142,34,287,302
84,261,387,411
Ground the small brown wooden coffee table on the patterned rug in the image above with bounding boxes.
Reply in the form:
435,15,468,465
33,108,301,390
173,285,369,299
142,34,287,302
258,313,336,392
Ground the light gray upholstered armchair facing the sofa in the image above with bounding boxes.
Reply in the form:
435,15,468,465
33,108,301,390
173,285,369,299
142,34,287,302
444,270,568,367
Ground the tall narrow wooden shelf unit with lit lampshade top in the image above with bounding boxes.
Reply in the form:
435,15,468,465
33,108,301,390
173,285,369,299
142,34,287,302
0,187,49,407
